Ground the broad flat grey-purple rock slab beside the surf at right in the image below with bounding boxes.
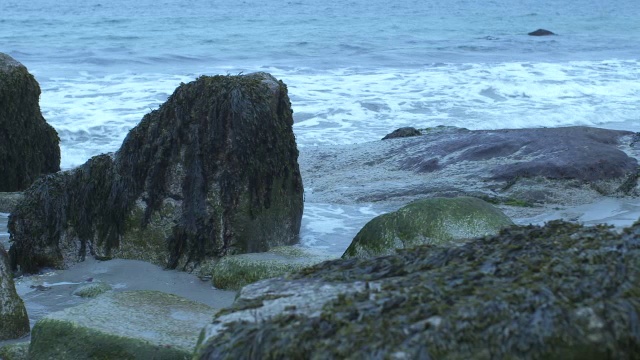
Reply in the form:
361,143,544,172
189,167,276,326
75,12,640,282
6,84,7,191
300,127,638,210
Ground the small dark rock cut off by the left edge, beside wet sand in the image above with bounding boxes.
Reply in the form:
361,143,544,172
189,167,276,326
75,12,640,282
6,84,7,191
0,244,29,340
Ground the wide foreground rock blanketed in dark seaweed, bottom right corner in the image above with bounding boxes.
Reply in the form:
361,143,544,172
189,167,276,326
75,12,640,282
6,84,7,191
197,222,640,360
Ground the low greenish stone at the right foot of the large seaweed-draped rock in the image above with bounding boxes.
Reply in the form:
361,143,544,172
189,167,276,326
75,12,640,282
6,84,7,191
199,246,331,290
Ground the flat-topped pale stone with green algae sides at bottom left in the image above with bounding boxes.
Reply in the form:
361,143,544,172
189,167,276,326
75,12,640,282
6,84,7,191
29,291,215,360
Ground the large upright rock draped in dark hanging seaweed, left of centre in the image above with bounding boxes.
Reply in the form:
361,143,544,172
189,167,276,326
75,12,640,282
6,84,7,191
8,73,303,272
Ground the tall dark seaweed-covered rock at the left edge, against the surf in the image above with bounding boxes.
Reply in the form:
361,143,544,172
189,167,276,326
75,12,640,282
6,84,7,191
0,53,60,191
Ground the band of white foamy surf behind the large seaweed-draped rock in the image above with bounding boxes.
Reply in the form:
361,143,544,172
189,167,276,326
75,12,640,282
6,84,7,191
33,60,640,168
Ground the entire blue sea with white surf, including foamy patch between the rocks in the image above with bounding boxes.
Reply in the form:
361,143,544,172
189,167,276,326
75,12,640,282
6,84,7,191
0,0,640,253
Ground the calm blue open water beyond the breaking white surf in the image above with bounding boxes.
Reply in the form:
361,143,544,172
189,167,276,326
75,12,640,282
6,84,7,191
0,0,640,75
